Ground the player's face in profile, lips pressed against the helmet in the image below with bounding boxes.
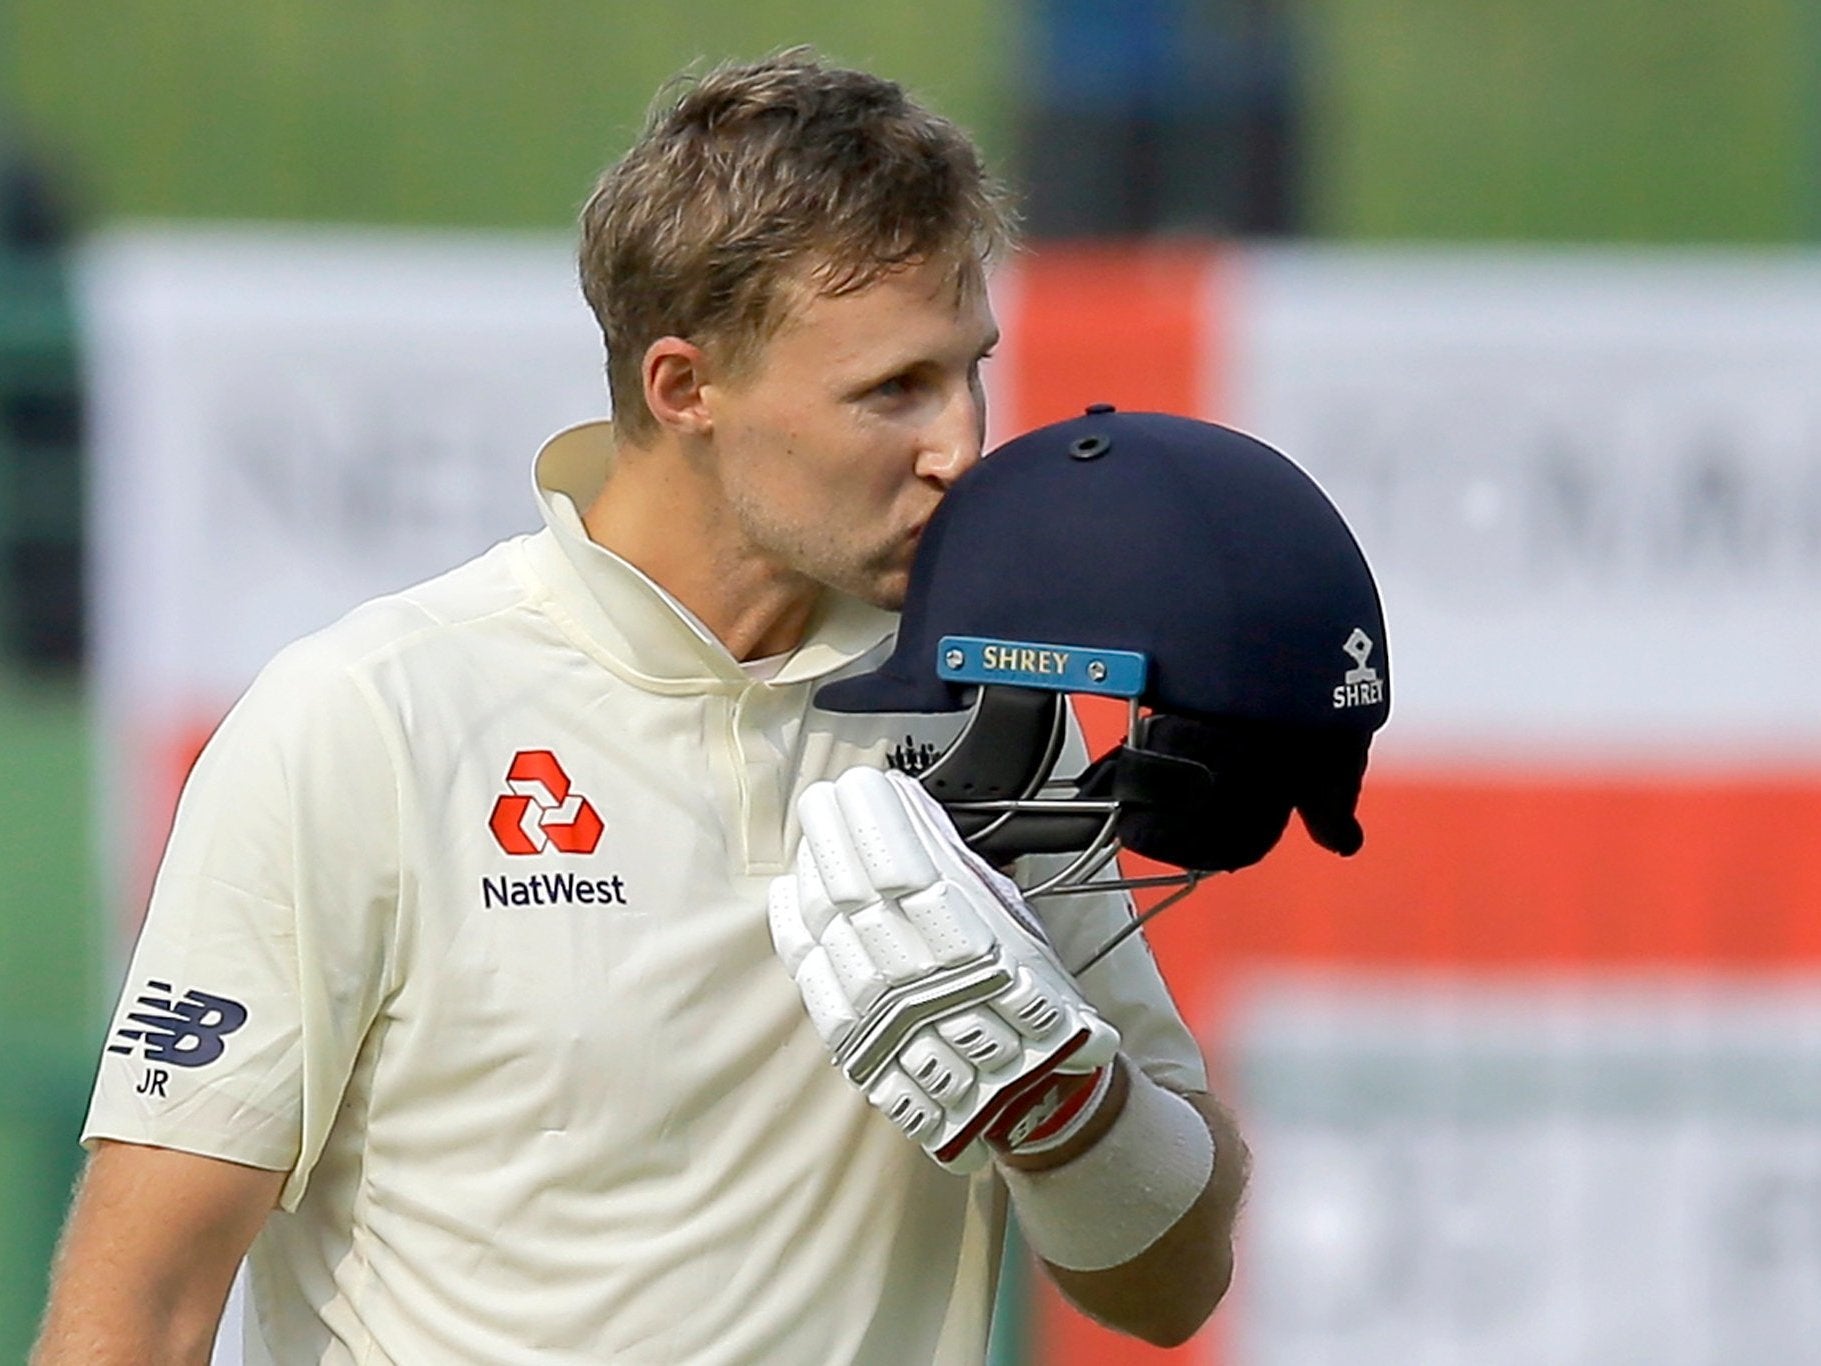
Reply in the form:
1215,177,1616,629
705,260,998,610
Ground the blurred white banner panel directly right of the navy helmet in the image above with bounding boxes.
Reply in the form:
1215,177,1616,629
1215,248,1821,767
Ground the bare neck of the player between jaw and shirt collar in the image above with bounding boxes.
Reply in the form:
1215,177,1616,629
581,433,821,659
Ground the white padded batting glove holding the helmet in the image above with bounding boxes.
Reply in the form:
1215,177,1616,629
770,769,1120,1171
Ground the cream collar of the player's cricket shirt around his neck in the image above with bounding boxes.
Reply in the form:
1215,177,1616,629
526,421,898,692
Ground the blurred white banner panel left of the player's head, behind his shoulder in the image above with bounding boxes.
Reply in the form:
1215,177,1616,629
82,229,606,698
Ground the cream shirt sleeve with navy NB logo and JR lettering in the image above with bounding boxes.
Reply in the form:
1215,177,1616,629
82,641,399,1208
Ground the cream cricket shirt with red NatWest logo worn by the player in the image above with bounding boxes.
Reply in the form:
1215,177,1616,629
86,424,1202,1366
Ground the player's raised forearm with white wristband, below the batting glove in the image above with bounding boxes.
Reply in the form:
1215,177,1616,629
1002,1062,1249,1346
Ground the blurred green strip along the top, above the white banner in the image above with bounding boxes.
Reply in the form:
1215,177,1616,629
0,0,1821,242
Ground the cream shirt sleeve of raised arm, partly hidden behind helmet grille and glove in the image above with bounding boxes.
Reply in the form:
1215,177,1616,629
1018,708,1207,1091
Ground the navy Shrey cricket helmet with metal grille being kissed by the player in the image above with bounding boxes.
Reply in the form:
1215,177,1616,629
816,404,1391,892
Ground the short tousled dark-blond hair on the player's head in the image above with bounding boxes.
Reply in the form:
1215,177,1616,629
579,47,1012,441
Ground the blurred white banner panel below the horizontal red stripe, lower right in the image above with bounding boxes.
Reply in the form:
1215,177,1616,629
1229,974,1821,1366
